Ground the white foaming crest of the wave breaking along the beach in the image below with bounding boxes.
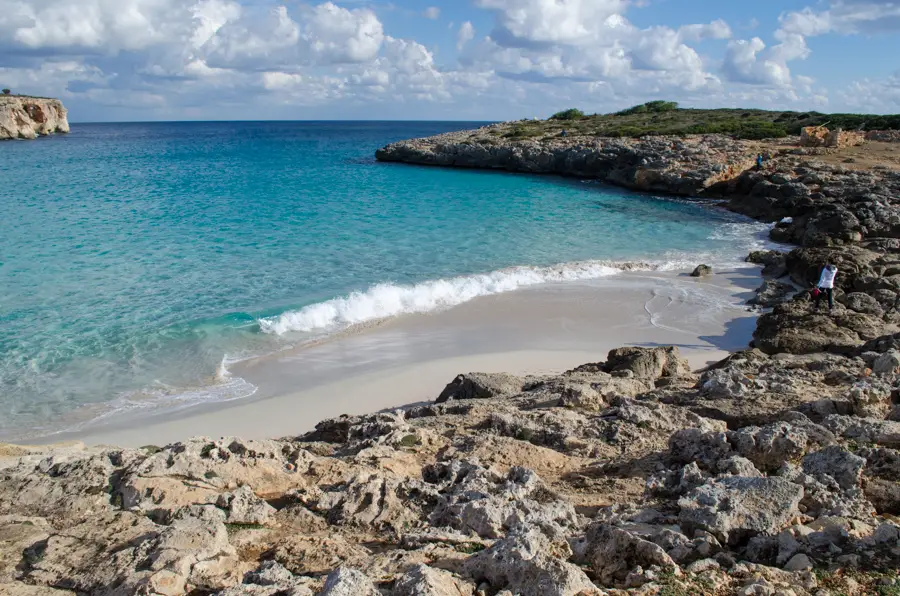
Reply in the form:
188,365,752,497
259,261,658,335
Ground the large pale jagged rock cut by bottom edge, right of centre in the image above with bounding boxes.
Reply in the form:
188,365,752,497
462,529,599,596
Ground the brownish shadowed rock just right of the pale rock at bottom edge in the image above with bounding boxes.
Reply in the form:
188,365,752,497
573,523,680,586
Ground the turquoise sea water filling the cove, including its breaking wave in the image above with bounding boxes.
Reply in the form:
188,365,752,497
0,122,761,436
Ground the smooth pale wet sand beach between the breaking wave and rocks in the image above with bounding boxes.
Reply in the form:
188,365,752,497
67,268,760,446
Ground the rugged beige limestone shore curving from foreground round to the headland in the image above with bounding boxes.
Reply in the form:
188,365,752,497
0,128,900,596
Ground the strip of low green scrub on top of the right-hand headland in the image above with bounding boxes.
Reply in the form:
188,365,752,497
497,101,900,140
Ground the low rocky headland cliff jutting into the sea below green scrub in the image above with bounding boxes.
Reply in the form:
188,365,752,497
375,124,756,196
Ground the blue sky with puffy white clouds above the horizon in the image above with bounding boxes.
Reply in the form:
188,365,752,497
0,0,900,122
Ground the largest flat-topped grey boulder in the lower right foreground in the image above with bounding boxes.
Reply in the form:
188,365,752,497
678,476,803,544
